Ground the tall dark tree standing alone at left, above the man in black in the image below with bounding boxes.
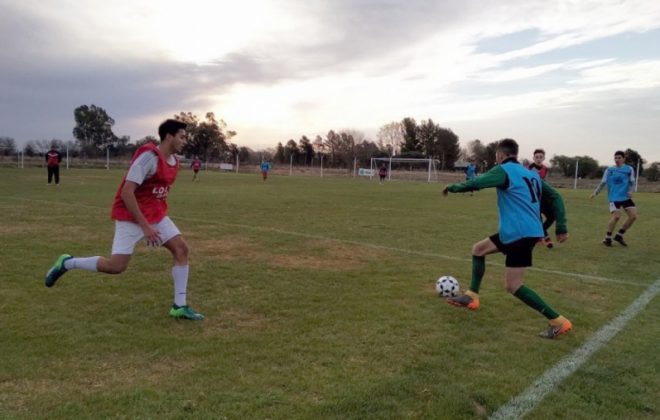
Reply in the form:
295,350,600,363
73,105,116,155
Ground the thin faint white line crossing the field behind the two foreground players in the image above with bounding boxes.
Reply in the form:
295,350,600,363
3,196,646,287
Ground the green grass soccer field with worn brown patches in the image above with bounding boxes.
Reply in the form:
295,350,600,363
0,168,660,419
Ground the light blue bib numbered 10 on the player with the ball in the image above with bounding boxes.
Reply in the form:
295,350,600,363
497,162,543,244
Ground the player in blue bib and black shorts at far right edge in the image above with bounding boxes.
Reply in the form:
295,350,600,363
590,150,637,246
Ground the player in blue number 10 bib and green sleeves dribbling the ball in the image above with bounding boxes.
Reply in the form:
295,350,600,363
442,139,573,338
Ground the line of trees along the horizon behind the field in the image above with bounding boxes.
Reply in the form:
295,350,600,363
0,105,660,181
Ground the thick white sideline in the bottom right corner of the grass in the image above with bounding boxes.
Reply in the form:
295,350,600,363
490,280,660,420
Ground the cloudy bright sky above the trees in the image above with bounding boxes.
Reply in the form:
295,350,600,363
0,0,660,165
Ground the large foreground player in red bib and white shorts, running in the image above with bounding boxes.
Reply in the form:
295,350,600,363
45,119,204,320
